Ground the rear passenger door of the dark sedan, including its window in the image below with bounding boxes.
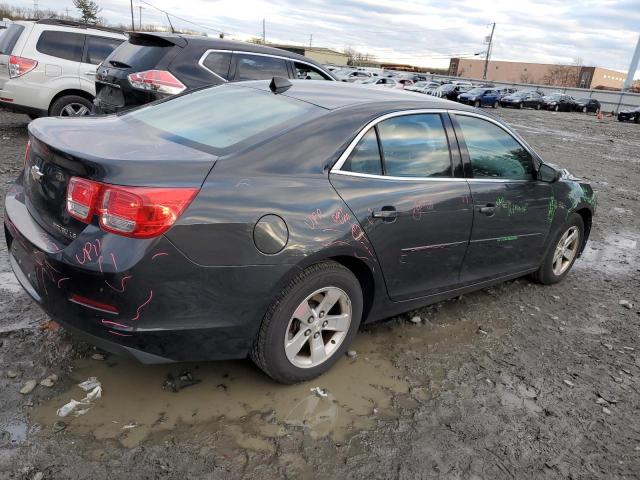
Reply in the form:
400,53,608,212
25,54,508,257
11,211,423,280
330,111,473,300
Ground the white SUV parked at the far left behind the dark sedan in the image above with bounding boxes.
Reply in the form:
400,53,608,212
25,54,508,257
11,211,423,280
0,19,126,118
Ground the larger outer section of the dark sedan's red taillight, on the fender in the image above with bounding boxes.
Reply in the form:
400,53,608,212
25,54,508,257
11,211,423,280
100,186,198,238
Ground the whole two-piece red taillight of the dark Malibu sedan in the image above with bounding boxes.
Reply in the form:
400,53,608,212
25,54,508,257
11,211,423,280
67,177,198,238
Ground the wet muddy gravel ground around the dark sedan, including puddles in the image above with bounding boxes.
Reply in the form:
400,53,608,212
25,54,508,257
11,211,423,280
0,109,640,480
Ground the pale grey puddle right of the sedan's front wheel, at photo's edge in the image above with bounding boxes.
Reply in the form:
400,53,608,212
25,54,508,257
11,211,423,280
575,232,640,273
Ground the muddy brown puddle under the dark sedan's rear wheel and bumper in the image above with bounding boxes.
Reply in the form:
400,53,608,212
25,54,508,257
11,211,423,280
31,334,408,450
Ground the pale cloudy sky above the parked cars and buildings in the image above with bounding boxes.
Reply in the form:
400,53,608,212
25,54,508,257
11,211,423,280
11,0,640,78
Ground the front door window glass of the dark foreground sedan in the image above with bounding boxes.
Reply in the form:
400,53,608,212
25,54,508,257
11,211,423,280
456,115,535,180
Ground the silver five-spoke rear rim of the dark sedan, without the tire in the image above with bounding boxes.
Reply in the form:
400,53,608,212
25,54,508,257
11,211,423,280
284,287,352,368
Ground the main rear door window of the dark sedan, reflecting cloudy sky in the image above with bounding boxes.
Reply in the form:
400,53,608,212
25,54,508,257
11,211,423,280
377,114,451,177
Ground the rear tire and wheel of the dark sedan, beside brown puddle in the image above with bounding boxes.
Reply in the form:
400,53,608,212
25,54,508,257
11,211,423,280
250,261,363,384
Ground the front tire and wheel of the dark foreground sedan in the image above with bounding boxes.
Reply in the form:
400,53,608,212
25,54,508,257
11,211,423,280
532,213,584,285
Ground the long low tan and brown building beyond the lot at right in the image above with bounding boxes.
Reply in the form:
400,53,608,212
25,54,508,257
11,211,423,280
449,58,626,90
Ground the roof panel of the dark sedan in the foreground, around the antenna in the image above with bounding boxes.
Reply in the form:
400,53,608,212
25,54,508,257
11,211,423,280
235,80,473,111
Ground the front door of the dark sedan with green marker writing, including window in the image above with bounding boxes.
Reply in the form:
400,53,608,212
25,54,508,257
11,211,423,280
453,113,553,283
